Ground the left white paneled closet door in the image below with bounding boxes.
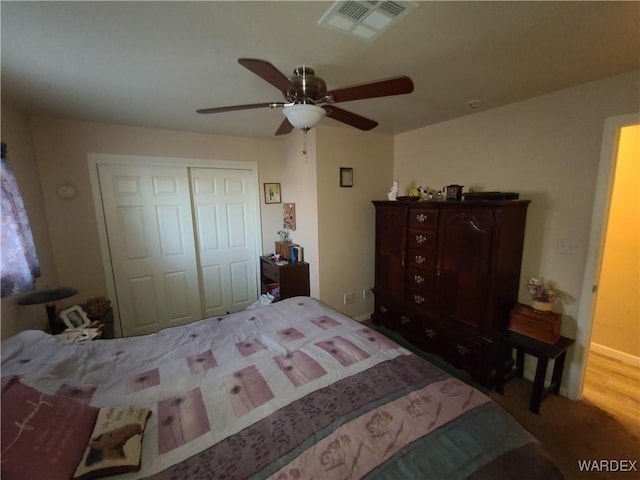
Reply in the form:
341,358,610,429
98,164,202,336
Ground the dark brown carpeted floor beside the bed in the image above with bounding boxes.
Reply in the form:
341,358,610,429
364,322,640,480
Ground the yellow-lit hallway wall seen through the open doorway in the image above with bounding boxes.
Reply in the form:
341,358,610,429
591,125,640,358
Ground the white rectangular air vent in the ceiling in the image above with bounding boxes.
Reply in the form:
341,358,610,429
318,0,418,40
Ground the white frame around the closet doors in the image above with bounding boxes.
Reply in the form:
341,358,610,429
87,153,262,336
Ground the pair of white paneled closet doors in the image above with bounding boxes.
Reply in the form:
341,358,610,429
98,164,258,336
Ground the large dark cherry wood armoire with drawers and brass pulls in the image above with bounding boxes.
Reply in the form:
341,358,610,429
372,200,529,386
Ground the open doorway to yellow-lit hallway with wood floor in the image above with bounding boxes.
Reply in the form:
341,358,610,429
576,114,640,424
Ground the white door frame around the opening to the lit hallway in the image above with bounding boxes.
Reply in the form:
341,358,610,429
567,112,640,400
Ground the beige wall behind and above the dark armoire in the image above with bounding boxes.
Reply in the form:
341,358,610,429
394,71,640,394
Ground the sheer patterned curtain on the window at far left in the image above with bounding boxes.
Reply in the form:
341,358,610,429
0,142,40,298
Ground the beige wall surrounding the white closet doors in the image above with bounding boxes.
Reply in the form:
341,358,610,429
23,116,283,314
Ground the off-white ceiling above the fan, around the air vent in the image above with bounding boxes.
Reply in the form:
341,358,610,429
1,1,640,138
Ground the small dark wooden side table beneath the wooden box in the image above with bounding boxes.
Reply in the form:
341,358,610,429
496,332,574,413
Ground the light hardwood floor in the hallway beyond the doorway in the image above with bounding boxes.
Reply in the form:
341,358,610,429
583,352,640,431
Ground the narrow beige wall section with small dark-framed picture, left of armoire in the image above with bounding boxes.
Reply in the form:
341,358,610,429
316,126,393,318
